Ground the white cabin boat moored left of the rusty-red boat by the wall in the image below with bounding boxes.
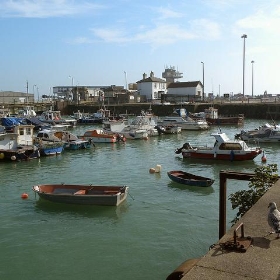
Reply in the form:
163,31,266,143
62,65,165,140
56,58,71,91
157,108,209,130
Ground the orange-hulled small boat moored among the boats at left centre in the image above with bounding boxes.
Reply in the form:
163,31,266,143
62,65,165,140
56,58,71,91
80,129,126,143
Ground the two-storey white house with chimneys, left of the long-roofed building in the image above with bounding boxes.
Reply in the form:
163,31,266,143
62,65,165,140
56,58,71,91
136,72,166,101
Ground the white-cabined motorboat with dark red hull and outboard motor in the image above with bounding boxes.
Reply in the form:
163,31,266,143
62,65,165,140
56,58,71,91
175,132,262,161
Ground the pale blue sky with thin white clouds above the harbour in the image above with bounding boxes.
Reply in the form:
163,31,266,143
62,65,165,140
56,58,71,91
0,0,280,96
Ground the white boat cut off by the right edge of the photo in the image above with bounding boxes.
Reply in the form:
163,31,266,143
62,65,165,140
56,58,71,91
236,123,280,143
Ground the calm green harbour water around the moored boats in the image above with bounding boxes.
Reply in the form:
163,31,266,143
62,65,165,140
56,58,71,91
0,120,280,280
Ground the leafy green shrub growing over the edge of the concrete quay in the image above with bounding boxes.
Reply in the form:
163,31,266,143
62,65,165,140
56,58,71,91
229,164,278,224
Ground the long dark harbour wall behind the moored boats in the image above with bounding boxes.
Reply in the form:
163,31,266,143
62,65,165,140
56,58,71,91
59,102,280,121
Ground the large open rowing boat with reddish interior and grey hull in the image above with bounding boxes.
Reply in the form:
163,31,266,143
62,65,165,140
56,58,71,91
32,184,128,206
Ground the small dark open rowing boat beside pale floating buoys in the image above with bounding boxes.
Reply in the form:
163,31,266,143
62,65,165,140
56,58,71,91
167,170,214,187
